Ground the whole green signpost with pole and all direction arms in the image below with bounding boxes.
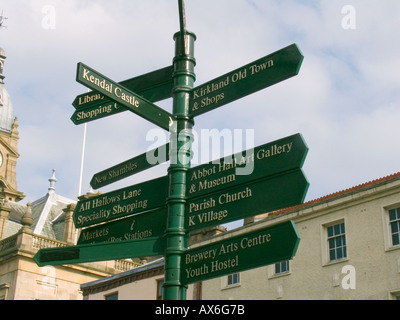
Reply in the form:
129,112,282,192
34,0,309,300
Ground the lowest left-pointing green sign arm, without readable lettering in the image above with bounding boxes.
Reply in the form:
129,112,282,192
33,238,165,267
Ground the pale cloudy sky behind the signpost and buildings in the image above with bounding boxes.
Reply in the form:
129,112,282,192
0,0,400,215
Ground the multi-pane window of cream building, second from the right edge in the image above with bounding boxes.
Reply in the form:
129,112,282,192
327,222,347,262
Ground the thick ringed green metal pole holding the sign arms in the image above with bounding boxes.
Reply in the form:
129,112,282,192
164,31,196,300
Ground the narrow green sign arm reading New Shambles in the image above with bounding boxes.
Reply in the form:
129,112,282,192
90,144,169,190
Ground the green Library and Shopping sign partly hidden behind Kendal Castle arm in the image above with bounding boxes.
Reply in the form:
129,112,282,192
71,66,173,125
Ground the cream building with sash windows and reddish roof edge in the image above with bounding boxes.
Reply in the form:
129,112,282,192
81,173,400,300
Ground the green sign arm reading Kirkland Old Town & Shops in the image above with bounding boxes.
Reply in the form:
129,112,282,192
190,44,304,117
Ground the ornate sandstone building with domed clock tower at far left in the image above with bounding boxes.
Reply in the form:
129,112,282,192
0,49,139,300
